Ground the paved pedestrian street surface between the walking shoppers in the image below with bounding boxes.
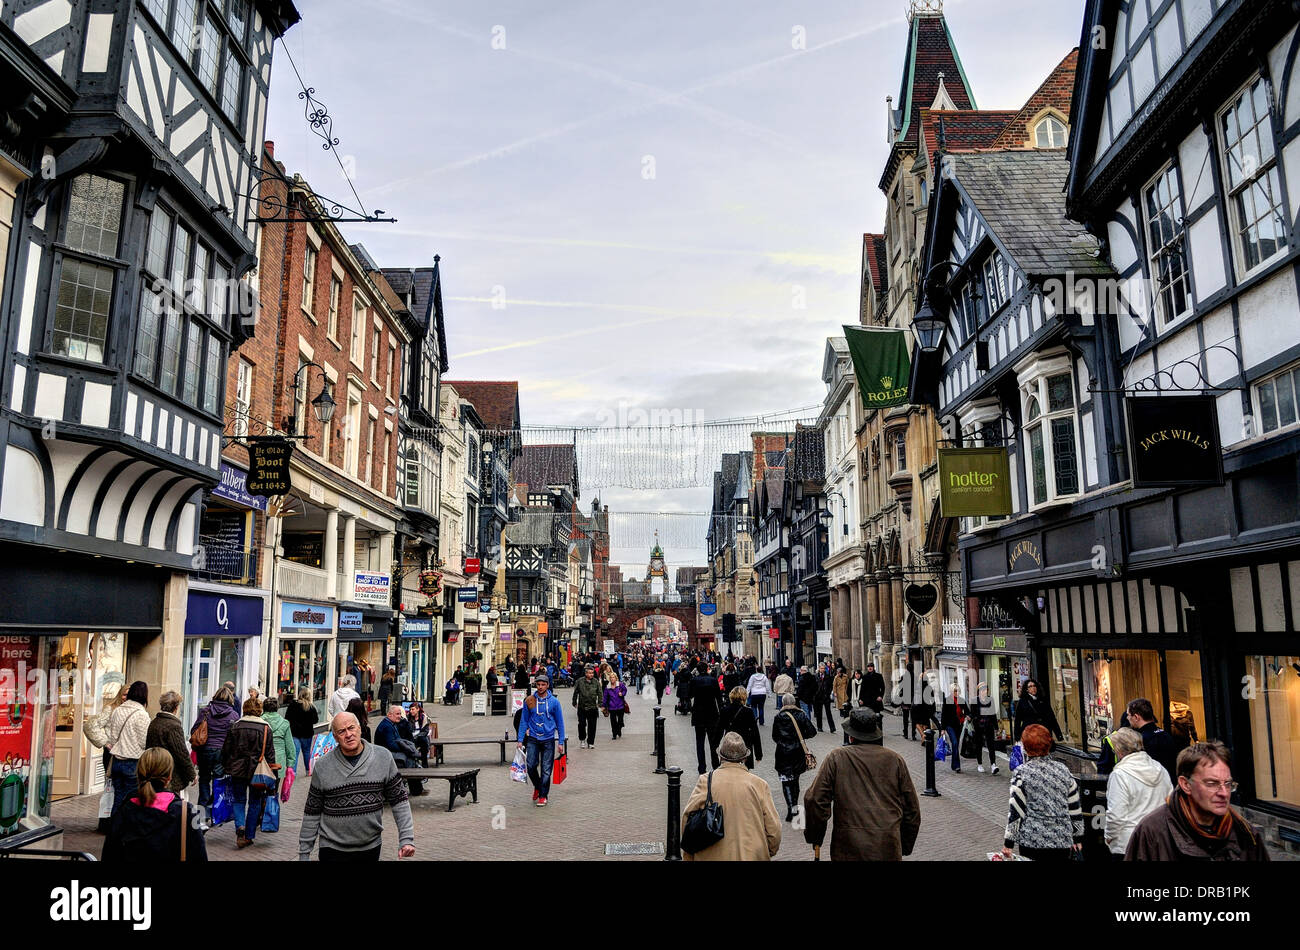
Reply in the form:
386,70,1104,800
53,689,1009,860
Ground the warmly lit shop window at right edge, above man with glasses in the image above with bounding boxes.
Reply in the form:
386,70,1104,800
1245,656,1300,807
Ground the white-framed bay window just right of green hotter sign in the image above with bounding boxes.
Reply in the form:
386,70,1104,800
1015,352,1080,511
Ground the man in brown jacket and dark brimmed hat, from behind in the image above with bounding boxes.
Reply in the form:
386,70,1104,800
803,708,920,860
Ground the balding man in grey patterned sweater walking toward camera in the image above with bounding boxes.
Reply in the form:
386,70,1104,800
298,712,415,862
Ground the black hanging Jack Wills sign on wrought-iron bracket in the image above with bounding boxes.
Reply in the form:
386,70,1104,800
1125,396,1223,489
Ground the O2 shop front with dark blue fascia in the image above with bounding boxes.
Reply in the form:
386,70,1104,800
179,590,265,725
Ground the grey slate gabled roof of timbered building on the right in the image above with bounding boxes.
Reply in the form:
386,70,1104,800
944,149,1110,279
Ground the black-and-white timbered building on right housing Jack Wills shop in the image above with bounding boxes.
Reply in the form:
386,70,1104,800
915,0,1300,853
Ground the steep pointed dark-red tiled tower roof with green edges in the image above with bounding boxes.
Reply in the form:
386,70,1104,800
880,13,976,190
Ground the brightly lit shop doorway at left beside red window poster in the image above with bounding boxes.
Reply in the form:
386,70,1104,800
51,630,127,798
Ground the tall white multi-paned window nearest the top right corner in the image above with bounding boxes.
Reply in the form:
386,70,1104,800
1218,77,1287,273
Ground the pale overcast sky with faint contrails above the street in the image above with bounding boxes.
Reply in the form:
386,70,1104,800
267,0,1083,572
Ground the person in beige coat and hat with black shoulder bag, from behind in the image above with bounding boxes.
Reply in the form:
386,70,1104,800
681,732,781,860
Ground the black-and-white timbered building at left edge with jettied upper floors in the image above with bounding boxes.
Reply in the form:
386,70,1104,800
0,0,299,849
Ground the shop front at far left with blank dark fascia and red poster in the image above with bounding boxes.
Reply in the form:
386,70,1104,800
0,545,175,849
